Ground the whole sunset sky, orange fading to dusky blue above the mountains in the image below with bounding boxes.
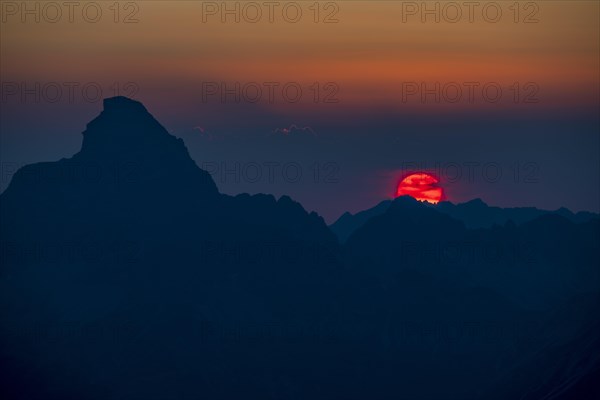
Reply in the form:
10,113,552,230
0,1,600,222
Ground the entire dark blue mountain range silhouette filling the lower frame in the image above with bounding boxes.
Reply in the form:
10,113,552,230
0,97,600,400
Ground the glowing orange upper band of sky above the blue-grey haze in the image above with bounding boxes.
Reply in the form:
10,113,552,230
0,1,600,110
